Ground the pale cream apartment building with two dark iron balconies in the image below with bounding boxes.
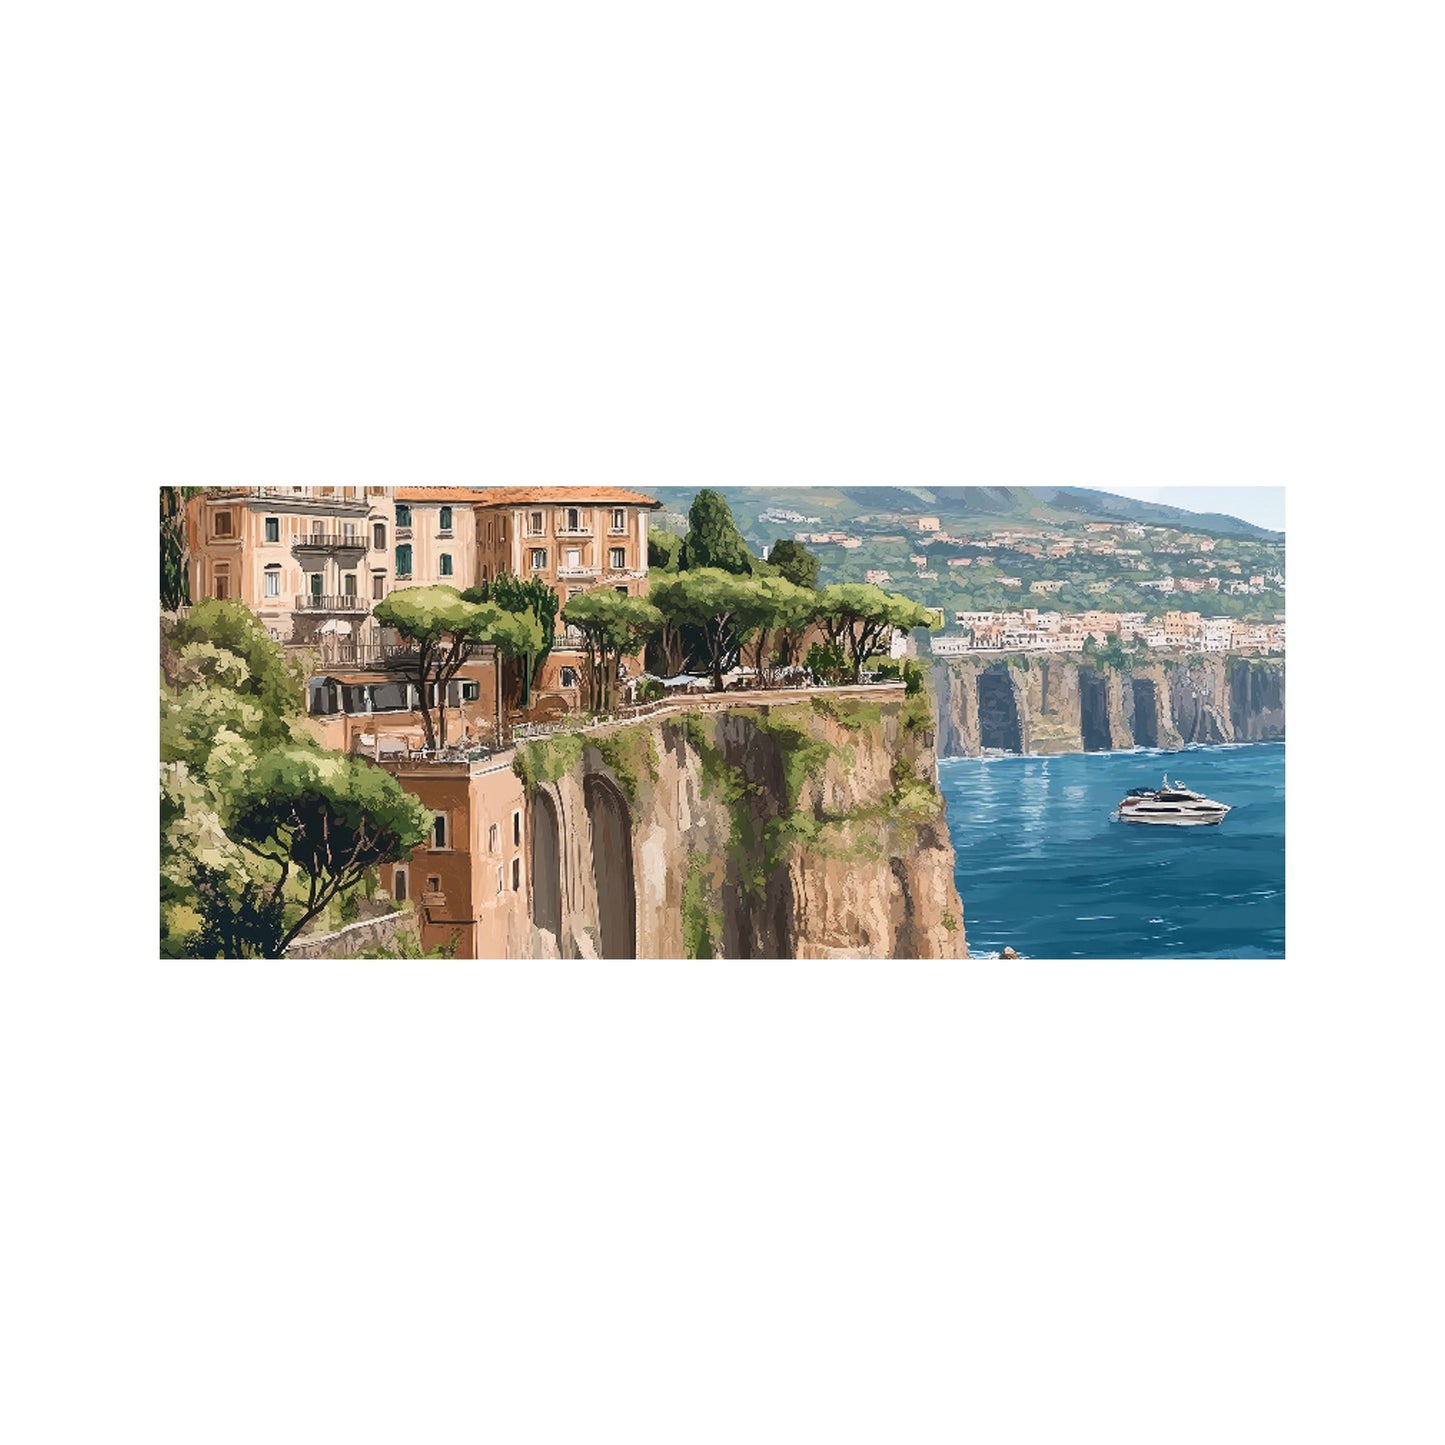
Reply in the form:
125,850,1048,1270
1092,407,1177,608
186,487,392,642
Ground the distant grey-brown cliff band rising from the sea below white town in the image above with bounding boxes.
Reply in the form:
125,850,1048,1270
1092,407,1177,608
933,653,1285,757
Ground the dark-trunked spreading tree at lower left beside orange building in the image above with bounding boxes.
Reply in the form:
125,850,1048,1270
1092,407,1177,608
222,747,432,958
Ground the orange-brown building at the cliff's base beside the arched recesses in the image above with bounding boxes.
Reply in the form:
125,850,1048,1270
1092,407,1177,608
381,759,530,958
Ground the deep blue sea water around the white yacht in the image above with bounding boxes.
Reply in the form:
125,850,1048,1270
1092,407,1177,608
938,743,1285,958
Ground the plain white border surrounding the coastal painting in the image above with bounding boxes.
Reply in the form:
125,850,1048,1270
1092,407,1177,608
0,3,1445,1445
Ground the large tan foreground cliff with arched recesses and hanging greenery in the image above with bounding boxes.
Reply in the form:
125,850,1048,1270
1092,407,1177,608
516,689,967,958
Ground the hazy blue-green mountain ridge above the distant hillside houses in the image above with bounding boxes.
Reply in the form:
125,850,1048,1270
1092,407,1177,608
653,487,1285,546
